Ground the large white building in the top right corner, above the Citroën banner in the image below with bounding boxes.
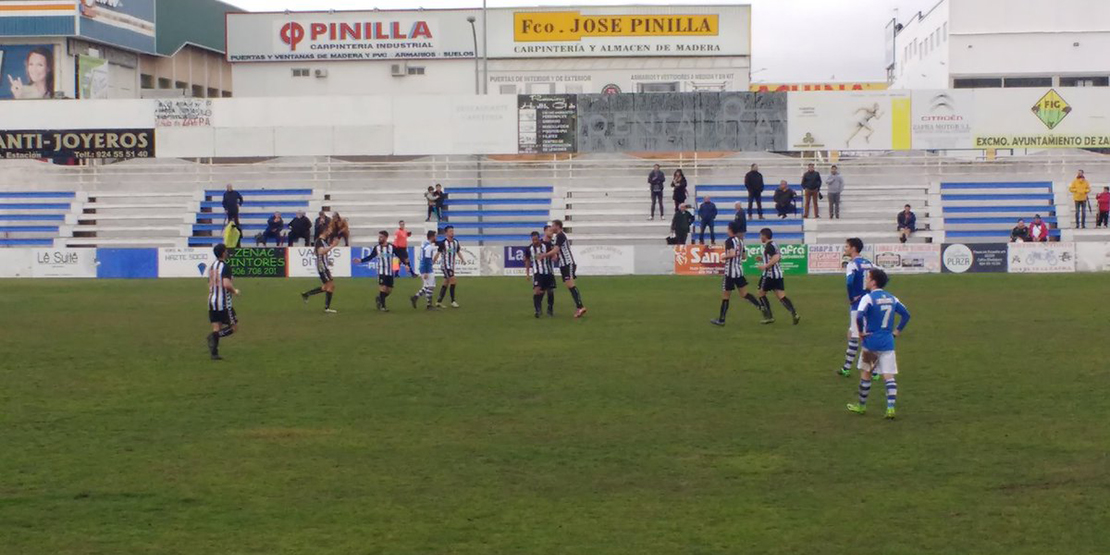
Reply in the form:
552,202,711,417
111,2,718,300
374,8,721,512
888,0,1110,89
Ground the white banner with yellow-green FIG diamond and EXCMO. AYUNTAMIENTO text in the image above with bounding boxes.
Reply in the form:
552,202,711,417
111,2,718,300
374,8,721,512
969,87,1110,149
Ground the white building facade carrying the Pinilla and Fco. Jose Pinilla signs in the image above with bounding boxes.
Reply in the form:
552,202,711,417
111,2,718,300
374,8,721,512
226,4,751,97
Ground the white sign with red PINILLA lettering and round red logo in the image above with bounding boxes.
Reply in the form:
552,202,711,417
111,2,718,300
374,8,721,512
228,10,482,62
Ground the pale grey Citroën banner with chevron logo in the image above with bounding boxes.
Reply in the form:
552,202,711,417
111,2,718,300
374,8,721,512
912,90,975,150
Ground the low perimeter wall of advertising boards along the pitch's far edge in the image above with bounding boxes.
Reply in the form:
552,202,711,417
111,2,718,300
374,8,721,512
0,242,1092,279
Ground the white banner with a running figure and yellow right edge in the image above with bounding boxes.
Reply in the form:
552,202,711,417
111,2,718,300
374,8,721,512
787,91,911,151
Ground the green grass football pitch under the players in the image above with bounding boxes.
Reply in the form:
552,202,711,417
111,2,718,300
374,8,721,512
0,275,1110,555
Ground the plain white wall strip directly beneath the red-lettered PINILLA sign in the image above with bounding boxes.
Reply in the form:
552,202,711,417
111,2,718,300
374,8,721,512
232,60,474,98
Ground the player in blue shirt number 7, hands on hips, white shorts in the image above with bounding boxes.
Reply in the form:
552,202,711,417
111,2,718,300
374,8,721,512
848,269,909,418
